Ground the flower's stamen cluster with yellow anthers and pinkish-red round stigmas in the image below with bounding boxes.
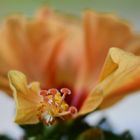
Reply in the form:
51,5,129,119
37,88,77,125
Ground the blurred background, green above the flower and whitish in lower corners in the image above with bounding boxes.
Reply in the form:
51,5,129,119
0,0,140,140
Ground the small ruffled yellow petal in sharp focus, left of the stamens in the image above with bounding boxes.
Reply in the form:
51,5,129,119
8,71,42,124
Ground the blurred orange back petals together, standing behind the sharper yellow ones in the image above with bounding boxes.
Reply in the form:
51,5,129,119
0,8,139,98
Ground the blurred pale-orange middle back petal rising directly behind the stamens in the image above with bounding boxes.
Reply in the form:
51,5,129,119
38,8,84,87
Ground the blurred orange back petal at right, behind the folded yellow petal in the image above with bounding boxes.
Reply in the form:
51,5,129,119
84,10,137,85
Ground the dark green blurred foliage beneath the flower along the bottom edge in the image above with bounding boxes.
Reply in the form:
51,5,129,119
21,117,133,140
